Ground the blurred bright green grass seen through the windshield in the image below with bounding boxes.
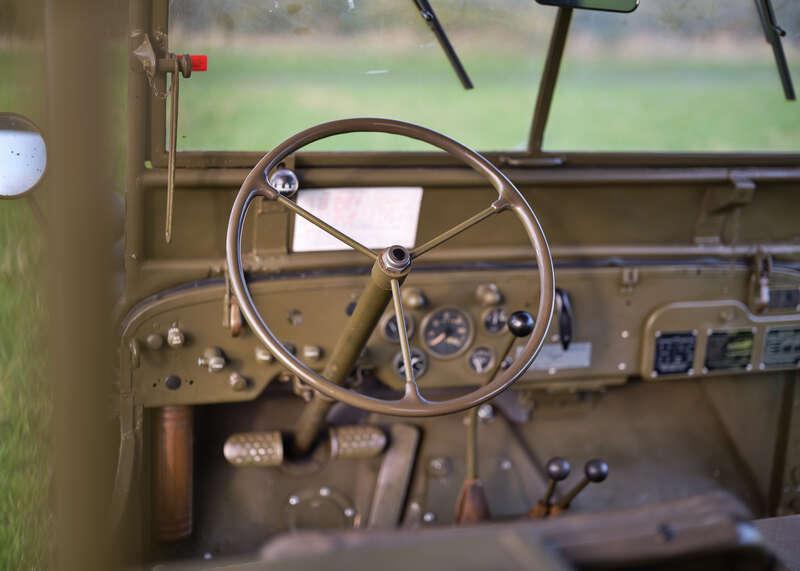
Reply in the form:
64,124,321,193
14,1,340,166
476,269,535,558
179,50,800,151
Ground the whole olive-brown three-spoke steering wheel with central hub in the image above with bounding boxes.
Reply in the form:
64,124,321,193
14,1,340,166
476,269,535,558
226,118,555,417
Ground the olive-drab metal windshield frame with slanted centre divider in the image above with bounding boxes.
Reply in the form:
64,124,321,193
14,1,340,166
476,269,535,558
147,0,800,168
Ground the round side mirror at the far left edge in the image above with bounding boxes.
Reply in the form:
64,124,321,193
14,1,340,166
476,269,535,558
0,113,47,198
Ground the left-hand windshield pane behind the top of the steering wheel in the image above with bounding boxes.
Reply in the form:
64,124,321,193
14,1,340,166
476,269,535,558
169,0,555,151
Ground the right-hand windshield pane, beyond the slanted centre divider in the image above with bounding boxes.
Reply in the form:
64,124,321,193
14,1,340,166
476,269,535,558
544,0,800,151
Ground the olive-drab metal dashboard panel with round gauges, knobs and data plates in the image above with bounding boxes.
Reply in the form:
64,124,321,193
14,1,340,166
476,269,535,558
122,263,800,406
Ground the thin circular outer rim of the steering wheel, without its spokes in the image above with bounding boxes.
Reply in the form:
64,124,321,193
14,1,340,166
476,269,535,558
226,118,555,417
